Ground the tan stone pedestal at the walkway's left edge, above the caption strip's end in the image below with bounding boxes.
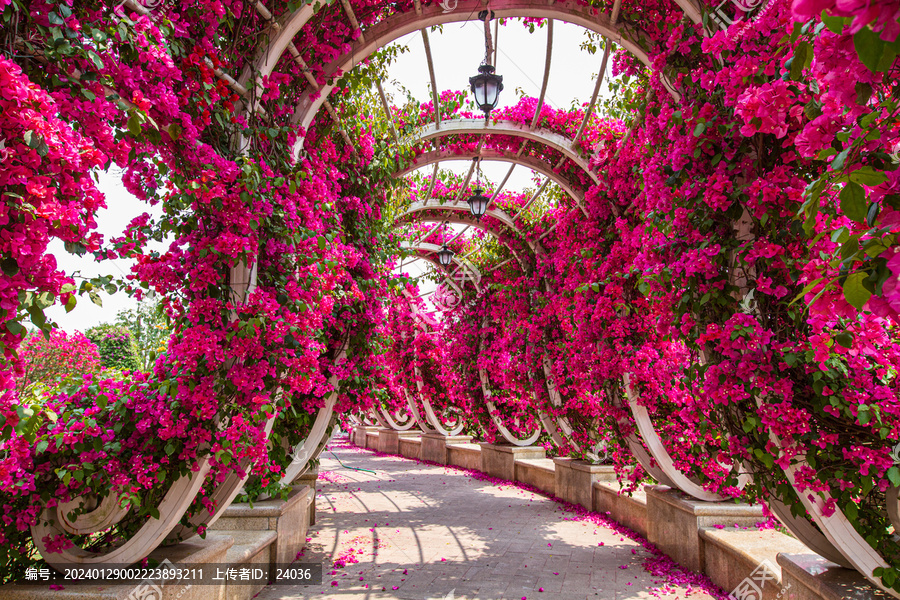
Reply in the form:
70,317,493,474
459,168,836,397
211,485,312,575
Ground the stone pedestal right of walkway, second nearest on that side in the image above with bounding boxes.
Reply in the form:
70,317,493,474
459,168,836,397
644,485,764,571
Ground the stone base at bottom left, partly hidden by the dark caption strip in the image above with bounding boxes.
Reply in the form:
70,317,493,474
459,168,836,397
0,532,232,600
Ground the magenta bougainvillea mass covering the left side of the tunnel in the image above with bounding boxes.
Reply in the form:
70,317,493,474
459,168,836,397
0,2,398,581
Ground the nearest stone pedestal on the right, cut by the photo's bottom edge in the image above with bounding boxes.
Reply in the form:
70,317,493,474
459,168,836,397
777,553,890,600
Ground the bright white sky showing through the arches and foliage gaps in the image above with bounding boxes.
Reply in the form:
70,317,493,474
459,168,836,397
47,20,607,331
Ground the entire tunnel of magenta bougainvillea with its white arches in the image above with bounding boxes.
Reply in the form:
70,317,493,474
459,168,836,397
0,0,900,597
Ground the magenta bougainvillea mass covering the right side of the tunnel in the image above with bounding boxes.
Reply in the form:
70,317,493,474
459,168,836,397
386,2,900,589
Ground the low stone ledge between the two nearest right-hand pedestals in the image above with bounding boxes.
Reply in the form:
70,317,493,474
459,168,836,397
700,525,809,600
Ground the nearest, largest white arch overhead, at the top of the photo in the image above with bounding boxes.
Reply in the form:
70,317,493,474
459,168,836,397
288,0,700,156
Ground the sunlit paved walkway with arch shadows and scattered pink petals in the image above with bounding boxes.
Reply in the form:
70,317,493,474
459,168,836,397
257,440,721,600
